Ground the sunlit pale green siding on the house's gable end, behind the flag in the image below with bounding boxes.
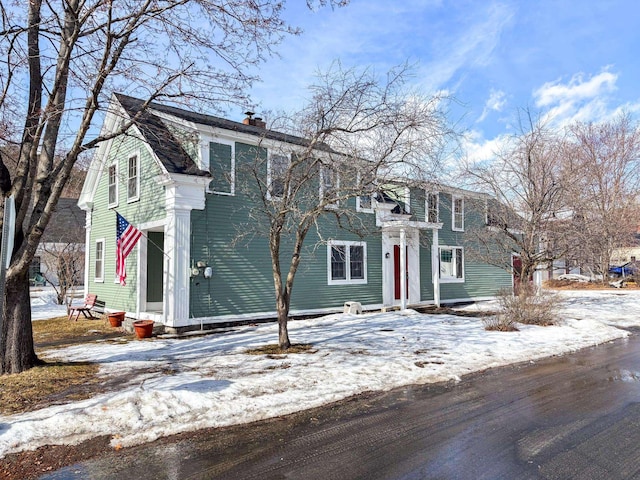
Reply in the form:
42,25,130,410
88,131,165,312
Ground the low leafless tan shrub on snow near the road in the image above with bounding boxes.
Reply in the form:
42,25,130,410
498,284,562,326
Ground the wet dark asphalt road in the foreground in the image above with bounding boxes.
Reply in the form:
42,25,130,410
42,335,640,480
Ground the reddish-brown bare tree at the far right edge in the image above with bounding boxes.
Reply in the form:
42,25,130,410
565,114,640,279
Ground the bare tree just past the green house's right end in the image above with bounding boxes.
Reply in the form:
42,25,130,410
466,111,573,280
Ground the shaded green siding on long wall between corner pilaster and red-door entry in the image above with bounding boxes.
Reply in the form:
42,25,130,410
190,143,382,318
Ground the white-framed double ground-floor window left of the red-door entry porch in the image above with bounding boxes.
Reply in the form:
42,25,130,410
327,240,367,285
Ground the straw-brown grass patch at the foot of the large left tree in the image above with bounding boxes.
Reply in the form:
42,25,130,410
0,362,102,415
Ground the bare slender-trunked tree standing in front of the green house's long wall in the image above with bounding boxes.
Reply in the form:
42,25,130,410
236,64,455,349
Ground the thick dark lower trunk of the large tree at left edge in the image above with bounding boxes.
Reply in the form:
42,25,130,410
0,272,41,374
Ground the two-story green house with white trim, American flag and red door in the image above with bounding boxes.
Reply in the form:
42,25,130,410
78,94,512,331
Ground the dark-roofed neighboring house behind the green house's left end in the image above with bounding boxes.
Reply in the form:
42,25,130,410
29,198,86,285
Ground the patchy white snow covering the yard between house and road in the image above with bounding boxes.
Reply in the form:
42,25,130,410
0,290,640,457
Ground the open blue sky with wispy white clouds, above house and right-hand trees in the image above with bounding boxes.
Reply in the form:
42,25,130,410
244,0,640,161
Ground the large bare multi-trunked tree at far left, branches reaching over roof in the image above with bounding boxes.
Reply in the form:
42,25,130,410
0,0,343,373
